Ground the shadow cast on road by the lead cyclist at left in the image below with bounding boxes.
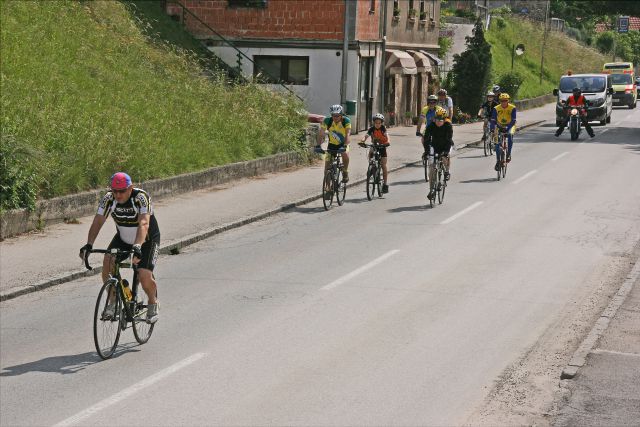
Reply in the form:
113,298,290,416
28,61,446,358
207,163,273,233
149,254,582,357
0,343,140,377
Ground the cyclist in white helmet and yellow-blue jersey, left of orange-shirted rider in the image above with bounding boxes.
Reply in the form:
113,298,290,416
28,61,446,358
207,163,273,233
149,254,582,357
316,104,351,183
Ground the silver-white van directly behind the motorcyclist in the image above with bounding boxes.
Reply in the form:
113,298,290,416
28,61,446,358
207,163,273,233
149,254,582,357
553,74,613,126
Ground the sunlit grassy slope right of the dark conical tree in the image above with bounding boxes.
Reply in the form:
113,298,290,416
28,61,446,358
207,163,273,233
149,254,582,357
485,17,611,99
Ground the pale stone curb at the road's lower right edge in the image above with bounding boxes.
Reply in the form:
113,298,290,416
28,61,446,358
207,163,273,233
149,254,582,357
560,259,640,380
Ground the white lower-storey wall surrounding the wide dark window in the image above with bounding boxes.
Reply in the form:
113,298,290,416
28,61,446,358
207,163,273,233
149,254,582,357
209,46,359,115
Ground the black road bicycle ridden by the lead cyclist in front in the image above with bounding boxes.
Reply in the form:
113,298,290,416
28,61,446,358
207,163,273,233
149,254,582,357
84,248,155,359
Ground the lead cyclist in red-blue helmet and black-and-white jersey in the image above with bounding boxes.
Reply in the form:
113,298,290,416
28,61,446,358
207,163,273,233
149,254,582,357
80,172,160,323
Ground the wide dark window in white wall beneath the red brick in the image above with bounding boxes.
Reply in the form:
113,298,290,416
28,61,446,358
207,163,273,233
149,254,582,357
253,55,309,85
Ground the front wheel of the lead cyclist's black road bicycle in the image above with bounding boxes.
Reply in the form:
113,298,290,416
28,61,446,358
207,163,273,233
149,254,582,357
93,280,126,359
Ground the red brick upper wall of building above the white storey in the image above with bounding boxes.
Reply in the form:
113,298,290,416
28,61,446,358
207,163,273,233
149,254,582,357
167,0,344,40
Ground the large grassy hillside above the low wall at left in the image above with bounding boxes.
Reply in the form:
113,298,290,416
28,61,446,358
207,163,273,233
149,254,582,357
0,0,305,209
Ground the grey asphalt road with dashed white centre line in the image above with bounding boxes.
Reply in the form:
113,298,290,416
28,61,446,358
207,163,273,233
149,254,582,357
0,109,640,425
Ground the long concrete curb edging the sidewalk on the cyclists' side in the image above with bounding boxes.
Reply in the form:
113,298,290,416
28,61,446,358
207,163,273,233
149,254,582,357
0,120,544,301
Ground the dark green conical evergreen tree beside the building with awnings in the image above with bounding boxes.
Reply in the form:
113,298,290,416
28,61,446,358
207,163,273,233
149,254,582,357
451,20,491,113
